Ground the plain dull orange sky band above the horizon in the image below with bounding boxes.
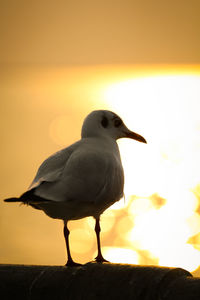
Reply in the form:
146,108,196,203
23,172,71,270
0,0,200,64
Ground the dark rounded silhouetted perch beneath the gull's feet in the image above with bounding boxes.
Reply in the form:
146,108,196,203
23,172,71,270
0,263,200,300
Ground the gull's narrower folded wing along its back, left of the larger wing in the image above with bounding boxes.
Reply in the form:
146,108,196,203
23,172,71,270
28,142,79,190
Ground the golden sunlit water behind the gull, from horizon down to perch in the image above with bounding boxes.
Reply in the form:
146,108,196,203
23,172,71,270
0,66,200,271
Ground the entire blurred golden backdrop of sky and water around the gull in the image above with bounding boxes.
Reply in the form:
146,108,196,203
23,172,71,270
0,0,200,274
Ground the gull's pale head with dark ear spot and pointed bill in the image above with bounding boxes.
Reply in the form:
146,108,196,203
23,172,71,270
81,110,146,143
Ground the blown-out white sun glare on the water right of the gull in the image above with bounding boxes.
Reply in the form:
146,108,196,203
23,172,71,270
99,75,200,271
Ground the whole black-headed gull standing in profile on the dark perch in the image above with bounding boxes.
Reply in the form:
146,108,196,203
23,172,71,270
4,110,146,267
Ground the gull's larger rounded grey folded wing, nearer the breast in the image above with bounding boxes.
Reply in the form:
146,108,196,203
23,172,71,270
36,148,123,202
